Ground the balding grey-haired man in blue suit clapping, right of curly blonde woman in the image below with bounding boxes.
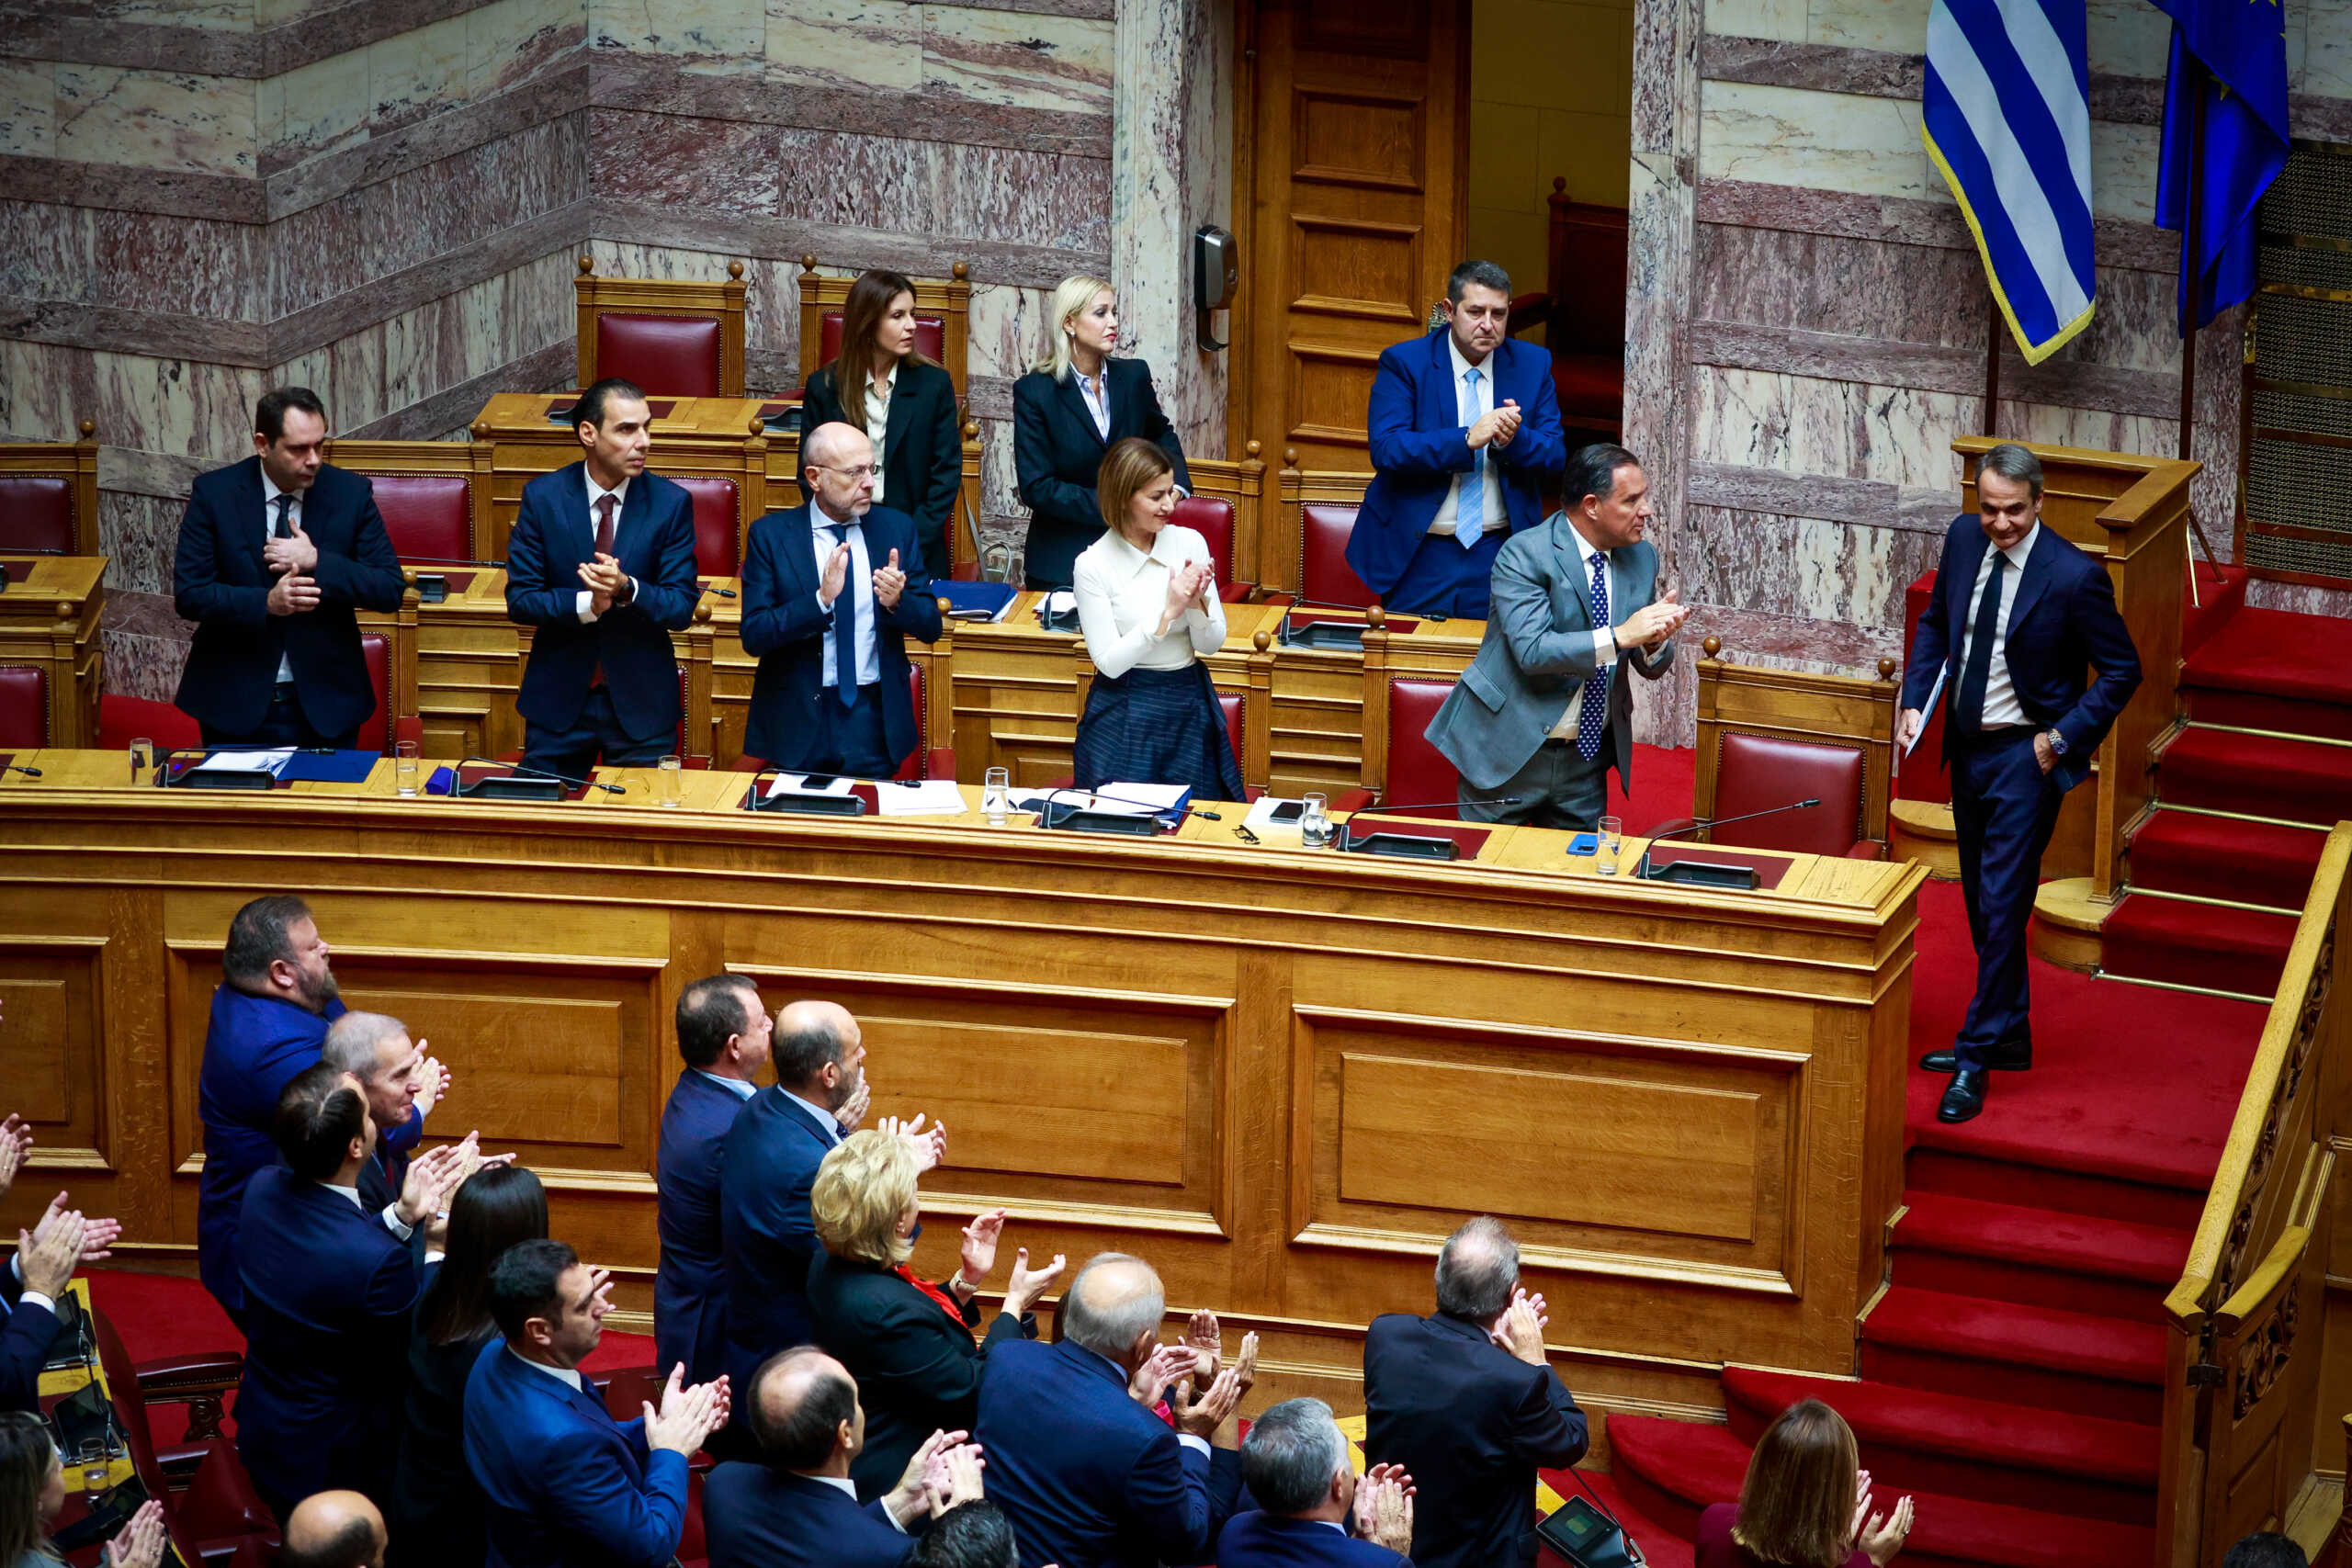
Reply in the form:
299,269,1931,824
974,1253,1250,1568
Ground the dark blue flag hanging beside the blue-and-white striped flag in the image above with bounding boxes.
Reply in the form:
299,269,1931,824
2154,0,2286,332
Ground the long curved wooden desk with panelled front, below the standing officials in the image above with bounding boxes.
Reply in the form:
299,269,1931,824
0,750,1922,1448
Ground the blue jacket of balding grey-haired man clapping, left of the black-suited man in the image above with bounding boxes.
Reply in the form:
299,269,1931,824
971,1340,1242,1568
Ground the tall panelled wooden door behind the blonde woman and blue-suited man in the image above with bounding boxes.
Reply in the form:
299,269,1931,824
1235,0,1470,472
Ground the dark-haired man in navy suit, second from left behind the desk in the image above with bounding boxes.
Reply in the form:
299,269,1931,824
505,378,703,778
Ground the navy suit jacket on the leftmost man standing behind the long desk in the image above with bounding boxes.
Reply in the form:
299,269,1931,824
172,456,404,736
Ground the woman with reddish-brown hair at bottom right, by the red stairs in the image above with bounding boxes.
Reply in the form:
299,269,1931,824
1696,1399,1912,1568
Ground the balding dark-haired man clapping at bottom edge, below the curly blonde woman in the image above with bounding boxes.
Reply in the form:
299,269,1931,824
703,1345,981,1568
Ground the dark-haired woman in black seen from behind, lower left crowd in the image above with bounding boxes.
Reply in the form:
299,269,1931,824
393,1166,548,1568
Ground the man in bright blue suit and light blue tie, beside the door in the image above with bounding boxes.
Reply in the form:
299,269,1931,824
1348,261,1566,621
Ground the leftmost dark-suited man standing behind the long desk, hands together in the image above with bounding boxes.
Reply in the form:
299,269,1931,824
172,386,404,750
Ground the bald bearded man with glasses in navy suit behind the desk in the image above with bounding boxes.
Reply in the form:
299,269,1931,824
743,423,941,778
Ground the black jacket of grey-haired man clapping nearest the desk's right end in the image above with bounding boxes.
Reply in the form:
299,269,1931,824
1364,1312,1585,1568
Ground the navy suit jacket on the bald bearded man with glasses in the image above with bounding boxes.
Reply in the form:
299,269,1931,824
743,505,941,769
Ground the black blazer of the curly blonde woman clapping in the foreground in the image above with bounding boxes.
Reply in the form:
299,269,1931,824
809,1251,1037,1502
